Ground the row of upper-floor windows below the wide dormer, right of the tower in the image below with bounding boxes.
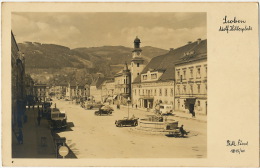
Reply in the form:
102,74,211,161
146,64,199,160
134,88,173,96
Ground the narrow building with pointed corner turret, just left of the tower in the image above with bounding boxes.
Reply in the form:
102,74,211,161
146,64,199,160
114,63,131,104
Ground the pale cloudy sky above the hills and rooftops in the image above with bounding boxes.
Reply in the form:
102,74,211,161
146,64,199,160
12,12,207,50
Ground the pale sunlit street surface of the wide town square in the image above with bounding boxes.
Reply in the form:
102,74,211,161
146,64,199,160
53,100,207,159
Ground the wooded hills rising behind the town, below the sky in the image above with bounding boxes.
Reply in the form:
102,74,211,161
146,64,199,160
18,42,168,84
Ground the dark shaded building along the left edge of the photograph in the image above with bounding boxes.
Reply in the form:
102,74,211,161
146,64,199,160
11,31,26,129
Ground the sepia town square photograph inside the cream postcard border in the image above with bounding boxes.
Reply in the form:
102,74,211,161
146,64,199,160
11,12,208,158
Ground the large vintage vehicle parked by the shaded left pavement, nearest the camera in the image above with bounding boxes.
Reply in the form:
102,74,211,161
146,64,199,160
49,108,67,129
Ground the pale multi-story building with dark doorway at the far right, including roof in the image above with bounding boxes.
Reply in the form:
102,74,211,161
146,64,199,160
175,39,207,115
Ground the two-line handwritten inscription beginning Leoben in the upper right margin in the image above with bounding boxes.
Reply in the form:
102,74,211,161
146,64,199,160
219,16,253,33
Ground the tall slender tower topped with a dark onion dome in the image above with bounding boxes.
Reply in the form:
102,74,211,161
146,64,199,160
131,36,144,83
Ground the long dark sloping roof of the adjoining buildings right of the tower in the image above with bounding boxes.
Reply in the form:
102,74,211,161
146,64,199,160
133,40,207,83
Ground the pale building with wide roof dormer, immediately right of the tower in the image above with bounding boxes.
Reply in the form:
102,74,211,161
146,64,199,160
132,50,178,108
